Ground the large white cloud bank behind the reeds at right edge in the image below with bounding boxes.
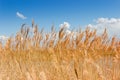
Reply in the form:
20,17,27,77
88,18,120,37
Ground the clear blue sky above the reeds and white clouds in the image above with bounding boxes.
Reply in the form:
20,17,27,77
0,0,120,36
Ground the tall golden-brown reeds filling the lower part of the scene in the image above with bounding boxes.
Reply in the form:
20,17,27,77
0,22,120,80
